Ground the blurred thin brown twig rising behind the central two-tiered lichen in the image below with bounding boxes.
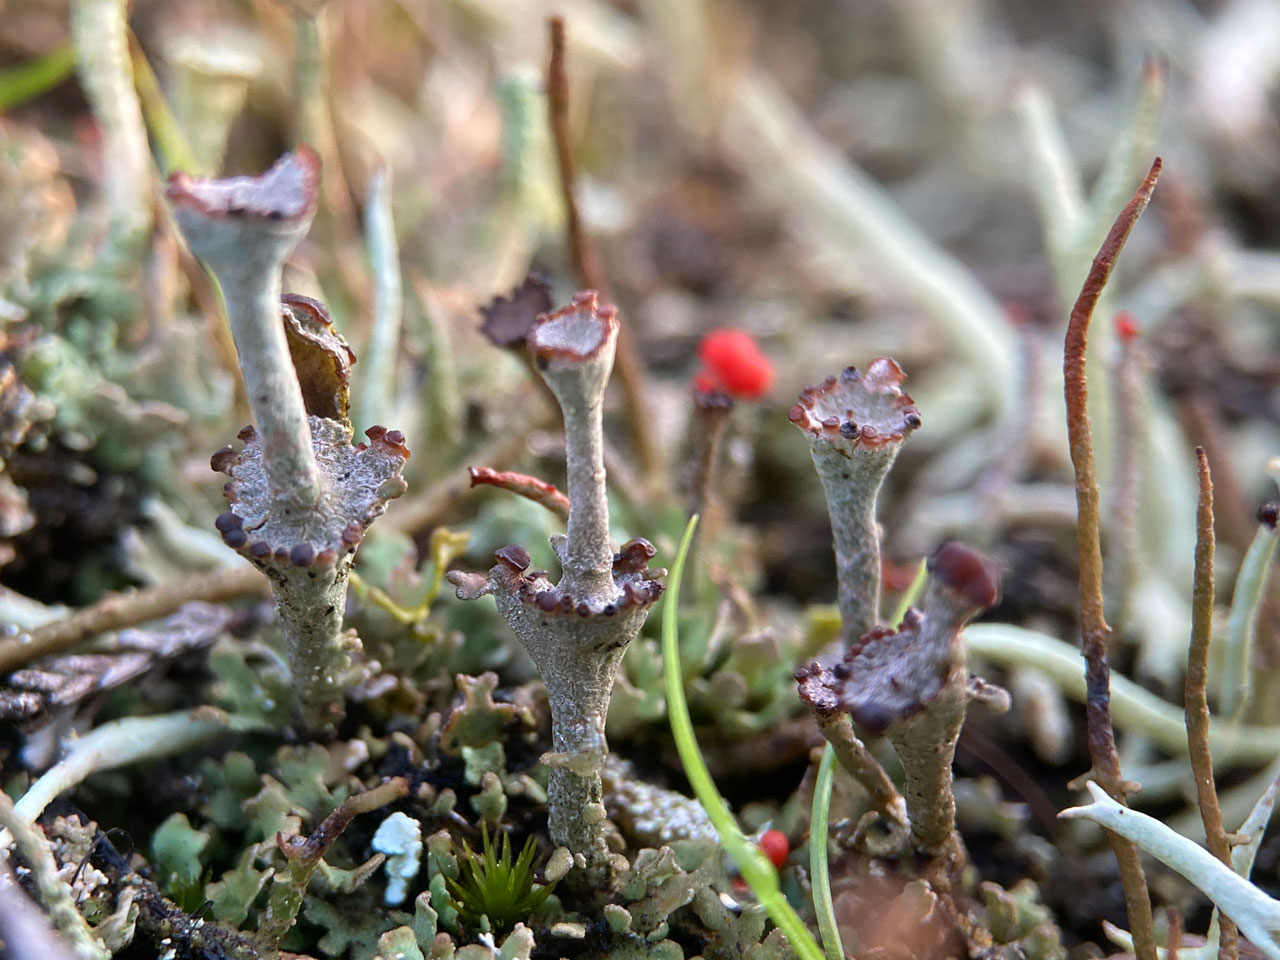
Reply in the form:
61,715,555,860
547,17,663,488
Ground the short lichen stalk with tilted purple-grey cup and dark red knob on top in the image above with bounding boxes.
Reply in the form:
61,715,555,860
796,541,1009,864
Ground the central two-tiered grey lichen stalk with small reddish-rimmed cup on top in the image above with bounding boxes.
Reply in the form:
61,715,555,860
449,292,666,863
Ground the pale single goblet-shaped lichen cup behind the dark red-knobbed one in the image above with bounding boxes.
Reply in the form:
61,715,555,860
790,357,920,646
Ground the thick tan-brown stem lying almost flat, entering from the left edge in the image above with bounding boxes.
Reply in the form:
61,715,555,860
0,564,268,675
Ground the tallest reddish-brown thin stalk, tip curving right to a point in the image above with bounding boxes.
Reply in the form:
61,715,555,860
1062,157,1161,960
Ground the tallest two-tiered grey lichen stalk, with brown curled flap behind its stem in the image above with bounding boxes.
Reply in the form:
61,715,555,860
168,147,408,735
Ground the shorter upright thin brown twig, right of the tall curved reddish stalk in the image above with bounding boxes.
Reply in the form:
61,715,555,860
1183,447,1239,960
